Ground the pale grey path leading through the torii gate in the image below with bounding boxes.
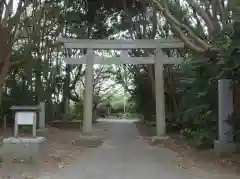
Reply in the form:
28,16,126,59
41,121,239,179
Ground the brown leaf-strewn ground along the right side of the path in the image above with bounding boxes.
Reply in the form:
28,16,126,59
137,123,240,173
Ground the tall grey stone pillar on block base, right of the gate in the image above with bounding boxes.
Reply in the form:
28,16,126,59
214,79,236,153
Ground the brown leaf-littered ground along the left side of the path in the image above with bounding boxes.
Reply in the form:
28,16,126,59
0,124,107,179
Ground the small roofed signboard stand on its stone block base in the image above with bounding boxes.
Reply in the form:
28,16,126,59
1,106,45,161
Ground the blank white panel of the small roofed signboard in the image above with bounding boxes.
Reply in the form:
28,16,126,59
15,112,36,125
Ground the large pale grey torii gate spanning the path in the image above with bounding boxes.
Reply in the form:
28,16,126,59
58,38,184,137
